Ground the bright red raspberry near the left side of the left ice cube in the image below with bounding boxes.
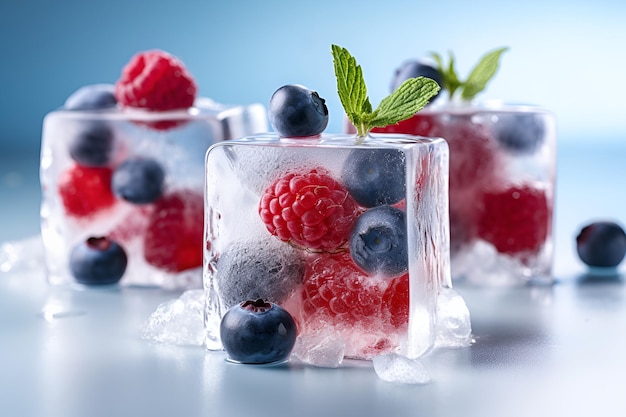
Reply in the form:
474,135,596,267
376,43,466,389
58,164,116,218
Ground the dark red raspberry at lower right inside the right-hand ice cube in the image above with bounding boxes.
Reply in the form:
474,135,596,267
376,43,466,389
477,185,551,255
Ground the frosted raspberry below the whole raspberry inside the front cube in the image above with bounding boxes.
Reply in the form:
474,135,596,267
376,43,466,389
302,252,387,324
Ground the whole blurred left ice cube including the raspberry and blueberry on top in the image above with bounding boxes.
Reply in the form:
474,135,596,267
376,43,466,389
40,50,267,288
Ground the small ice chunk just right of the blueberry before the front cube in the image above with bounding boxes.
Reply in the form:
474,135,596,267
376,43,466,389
292,332,346,368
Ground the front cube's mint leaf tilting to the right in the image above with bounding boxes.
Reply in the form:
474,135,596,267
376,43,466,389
368,77,441,127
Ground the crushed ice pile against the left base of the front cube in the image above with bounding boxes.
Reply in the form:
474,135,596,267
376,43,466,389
142,290,204,346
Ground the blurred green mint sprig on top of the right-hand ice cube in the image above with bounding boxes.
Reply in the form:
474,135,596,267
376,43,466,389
431,47,509,101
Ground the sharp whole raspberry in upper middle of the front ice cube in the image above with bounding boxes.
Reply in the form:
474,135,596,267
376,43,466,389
259,169,359,252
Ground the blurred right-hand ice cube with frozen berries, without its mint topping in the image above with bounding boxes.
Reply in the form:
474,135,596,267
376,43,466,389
366,102,556,285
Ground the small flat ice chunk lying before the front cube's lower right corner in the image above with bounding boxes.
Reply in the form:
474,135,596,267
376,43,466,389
372,353,430,384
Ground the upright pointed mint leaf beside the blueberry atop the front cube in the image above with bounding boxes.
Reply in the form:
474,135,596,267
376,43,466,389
331,45,372,135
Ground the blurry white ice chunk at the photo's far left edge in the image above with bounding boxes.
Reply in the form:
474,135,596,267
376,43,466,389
0,235,44,272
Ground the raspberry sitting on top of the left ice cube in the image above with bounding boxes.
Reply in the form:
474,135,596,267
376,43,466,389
115,50,197,111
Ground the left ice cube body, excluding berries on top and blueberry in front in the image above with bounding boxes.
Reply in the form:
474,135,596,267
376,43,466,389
40,98,267,288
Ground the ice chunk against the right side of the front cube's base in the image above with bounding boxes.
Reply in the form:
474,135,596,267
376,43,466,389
435,288,472,347
